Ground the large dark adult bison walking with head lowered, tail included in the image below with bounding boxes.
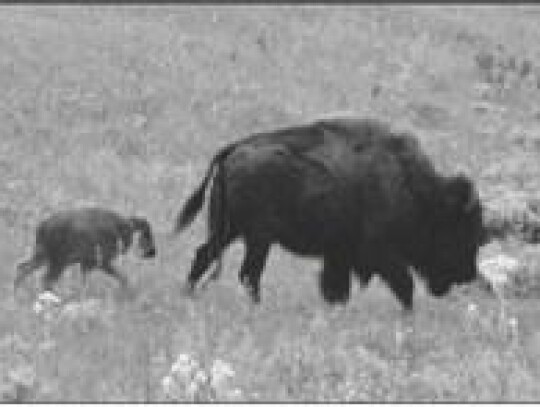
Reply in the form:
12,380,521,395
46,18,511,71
176,119,483,310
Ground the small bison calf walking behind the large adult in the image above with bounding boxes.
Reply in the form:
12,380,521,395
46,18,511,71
15,208,156,290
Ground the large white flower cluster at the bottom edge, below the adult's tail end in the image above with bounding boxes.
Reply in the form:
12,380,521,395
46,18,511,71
161,354,242,402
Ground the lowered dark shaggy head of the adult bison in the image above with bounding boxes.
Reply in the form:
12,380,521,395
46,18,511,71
421,175,483,296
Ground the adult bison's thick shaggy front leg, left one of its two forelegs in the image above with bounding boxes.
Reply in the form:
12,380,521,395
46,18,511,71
319,255,351,304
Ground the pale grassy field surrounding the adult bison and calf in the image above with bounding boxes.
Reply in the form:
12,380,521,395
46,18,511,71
0,5,540,402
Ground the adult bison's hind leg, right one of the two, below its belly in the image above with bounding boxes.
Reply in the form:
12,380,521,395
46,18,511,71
238,241,270,303
